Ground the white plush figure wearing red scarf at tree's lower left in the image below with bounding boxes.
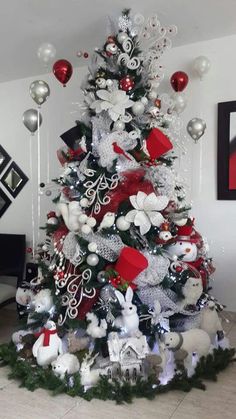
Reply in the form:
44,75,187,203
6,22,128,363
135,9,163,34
32,320,63,367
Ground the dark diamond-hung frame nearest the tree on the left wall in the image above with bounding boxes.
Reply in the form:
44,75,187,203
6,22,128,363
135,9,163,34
1,162,29,198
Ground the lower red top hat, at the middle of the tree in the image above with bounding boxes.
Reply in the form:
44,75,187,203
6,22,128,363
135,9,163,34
115,247,148,282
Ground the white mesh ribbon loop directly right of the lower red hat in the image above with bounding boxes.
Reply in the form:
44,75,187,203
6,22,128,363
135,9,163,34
134,251,170,288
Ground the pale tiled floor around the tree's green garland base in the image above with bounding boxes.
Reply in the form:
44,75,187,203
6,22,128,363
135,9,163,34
0,310,236,419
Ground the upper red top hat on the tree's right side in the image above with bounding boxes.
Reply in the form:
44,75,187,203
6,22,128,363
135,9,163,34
146,128,173,160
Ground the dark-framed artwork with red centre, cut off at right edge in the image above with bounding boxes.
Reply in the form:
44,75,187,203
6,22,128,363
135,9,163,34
217,101,236,200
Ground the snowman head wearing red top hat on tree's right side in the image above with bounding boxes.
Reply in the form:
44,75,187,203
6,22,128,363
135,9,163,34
167,225,198,263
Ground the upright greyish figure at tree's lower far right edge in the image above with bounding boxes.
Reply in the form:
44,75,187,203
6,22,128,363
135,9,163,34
200,301,224,344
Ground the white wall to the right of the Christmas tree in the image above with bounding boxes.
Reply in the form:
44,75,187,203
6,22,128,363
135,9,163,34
162,36,236,310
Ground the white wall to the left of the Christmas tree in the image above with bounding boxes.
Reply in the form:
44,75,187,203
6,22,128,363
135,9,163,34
0,68,85,246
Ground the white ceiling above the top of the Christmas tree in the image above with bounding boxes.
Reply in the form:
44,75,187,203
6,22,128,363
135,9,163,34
0,0,236,82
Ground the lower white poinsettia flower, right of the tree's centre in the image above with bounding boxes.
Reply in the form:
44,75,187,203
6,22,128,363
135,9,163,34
125,191,169,234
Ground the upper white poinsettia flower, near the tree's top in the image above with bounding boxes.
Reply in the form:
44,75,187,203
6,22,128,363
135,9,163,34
90,89,134,121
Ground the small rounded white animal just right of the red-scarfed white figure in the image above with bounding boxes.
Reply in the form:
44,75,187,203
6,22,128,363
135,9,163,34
51,353,80,380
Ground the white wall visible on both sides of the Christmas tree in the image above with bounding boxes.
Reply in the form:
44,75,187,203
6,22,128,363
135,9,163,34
0,36,236,310
